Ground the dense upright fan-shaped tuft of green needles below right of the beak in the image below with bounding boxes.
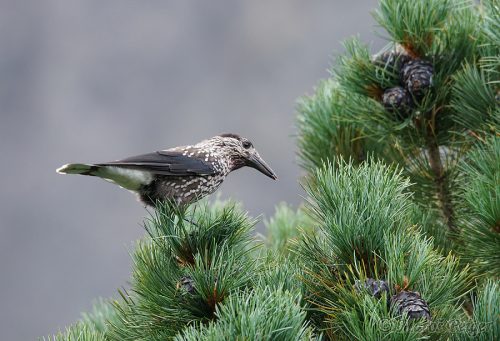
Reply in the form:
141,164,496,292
298,160,411,275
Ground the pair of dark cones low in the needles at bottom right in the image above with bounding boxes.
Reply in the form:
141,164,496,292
354,278,431,320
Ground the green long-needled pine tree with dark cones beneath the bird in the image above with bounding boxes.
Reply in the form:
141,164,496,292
49,0,500,340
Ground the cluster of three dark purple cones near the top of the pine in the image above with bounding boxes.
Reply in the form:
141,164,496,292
374,46,434,119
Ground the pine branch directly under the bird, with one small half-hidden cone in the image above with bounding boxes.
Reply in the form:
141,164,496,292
108,199,257,340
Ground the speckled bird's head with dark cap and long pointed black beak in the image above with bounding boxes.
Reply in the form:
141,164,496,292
208,134,278,180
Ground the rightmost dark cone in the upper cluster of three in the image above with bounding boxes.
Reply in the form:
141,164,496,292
401,59,434,97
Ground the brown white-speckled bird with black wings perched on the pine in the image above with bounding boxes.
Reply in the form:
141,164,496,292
57,133,278,207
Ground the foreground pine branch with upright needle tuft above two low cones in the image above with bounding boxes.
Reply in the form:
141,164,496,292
297,160,470,340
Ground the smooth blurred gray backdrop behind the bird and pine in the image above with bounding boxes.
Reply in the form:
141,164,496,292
0,0,384,340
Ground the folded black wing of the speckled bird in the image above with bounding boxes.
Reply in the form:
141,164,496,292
97,150,215,176
